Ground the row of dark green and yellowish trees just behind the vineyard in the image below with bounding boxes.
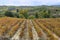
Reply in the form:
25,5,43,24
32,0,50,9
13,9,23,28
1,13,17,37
0,9,60,19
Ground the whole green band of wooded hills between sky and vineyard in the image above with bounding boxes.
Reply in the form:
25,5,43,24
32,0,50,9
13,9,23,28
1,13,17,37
0,5,60,19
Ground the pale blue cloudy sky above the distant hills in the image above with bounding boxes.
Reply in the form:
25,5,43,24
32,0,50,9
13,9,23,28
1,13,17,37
0,0,60,6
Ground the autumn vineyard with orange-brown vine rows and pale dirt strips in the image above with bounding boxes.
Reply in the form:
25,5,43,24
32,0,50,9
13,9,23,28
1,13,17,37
0,17,60,40
